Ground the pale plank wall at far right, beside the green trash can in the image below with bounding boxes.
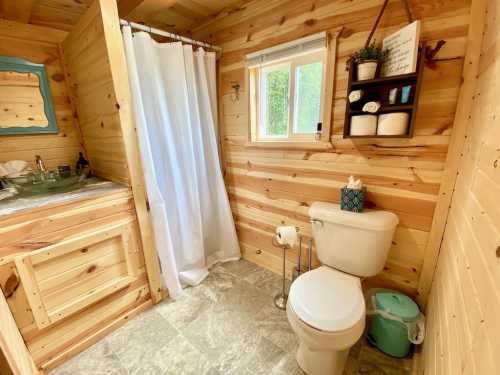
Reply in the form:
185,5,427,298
421,0,500,375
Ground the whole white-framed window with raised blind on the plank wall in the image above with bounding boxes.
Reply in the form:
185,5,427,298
247,33,333,143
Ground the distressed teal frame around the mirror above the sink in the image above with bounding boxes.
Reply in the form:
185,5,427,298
0,56,59,135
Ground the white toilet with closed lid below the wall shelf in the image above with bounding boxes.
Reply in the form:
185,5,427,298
286,202,398,375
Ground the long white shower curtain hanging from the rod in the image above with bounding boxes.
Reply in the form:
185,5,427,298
123,26,240,298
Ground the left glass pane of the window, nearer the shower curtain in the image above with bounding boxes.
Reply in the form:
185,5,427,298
262,66,290,137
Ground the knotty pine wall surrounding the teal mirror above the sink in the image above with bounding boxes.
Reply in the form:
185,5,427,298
0,20,82,168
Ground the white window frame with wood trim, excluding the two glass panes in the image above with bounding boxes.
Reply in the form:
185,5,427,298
246,33,336,148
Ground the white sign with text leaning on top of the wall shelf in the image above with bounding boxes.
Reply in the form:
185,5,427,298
382,21,420,77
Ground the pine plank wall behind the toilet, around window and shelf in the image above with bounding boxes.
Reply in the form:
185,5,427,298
193,0,470,295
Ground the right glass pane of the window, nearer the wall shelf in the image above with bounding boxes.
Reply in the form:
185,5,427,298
293,62,323,134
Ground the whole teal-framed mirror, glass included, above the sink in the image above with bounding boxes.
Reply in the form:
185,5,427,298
0,56,58,135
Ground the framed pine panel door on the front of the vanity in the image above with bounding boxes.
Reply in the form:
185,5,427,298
15,222,136,329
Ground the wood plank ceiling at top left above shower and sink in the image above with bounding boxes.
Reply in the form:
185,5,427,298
0,0,249,34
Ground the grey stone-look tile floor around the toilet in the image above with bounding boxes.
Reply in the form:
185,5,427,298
50,260,412,375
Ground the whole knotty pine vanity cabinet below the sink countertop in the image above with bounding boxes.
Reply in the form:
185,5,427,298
0,189,153,370
